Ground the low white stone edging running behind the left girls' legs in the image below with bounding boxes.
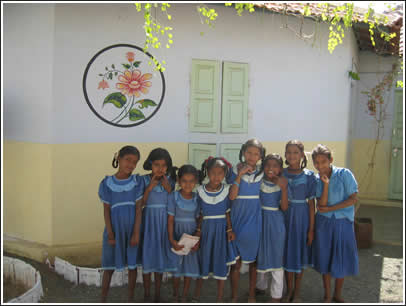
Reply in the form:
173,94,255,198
54,256,170,287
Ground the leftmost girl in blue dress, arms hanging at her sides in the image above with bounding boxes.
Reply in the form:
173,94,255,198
99,146,144,303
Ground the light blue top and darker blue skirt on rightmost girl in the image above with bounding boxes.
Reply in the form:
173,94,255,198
313,166,358,278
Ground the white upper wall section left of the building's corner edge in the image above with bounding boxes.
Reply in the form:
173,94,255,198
2,3,55,143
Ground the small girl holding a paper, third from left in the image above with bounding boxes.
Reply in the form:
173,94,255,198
168,165,200,303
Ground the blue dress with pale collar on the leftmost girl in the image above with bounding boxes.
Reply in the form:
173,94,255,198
99,174,144,271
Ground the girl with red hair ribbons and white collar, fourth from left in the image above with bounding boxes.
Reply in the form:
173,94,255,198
196,157,238,303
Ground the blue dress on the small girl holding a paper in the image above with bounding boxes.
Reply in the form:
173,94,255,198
168,191,200,278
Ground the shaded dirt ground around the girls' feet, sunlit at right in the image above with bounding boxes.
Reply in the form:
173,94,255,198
4,244,404,303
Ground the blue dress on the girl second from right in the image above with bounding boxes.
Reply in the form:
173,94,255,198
283,169,316,273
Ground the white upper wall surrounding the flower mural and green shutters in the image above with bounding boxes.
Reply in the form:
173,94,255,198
4,3,355,143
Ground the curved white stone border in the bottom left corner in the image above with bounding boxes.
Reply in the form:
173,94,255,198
3,256,44,303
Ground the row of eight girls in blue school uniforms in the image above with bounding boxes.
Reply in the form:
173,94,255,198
99,139,358,303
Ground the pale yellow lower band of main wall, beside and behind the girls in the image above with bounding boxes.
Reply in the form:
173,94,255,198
4,141,347,250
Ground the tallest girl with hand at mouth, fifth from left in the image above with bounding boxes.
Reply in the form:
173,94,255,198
227,139,265,303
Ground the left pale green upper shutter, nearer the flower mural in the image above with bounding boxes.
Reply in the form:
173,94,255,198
189,59,220,133
